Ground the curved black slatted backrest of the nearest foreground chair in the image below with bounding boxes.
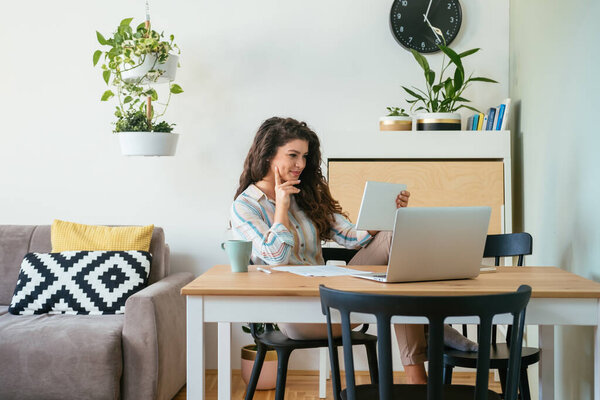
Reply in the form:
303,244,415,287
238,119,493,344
319,285,531,400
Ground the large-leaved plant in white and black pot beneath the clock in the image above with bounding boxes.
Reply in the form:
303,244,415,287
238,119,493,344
402,45,498,131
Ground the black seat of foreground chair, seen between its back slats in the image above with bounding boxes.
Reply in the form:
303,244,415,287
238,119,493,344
341,385,501,400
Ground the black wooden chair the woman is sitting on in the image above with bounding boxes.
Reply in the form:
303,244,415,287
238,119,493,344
245,248,377,400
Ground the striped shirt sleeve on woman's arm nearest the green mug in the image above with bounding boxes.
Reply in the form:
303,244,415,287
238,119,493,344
231,199,294,265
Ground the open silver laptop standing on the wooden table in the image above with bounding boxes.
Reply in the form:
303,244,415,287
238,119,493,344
352,207,492,282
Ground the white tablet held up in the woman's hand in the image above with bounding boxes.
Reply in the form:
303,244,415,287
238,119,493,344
356,181,406,231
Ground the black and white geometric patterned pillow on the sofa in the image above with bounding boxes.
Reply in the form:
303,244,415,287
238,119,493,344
8,251,152,315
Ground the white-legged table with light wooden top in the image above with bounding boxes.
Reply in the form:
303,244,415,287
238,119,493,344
182,266,600,400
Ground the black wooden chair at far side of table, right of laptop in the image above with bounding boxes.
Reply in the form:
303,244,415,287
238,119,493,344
444,232,540,400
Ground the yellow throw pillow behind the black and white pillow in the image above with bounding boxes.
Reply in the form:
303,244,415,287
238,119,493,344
50,219,154,253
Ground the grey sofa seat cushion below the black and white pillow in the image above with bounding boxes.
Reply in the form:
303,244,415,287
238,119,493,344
0,314,124,400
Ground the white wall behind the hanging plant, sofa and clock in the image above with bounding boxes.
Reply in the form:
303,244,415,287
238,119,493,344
0,0,508,369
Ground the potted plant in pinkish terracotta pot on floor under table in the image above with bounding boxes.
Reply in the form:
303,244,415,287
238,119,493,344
241,323,279,390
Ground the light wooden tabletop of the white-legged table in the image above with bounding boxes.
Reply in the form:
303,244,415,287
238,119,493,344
181,265,600,298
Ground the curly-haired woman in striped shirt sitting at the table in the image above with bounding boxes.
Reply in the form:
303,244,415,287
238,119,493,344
231,117,474,383
